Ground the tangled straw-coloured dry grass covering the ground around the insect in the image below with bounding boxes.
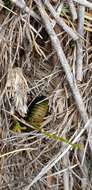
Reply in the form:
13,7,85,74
0,1,92,190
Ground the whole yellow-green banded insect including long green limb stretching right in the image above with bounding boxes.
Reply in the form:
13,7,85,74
12,96,80,148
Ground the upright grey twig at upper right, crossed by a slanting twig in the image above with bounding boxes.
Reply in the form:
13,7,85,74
76,5,85,81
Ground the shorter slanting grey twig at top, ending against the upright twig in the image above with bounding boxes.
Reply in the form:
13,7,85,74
45,0,79,41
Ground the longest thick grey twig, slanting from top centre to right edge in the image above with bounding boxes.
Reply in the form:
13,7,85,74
35,0,88,123
